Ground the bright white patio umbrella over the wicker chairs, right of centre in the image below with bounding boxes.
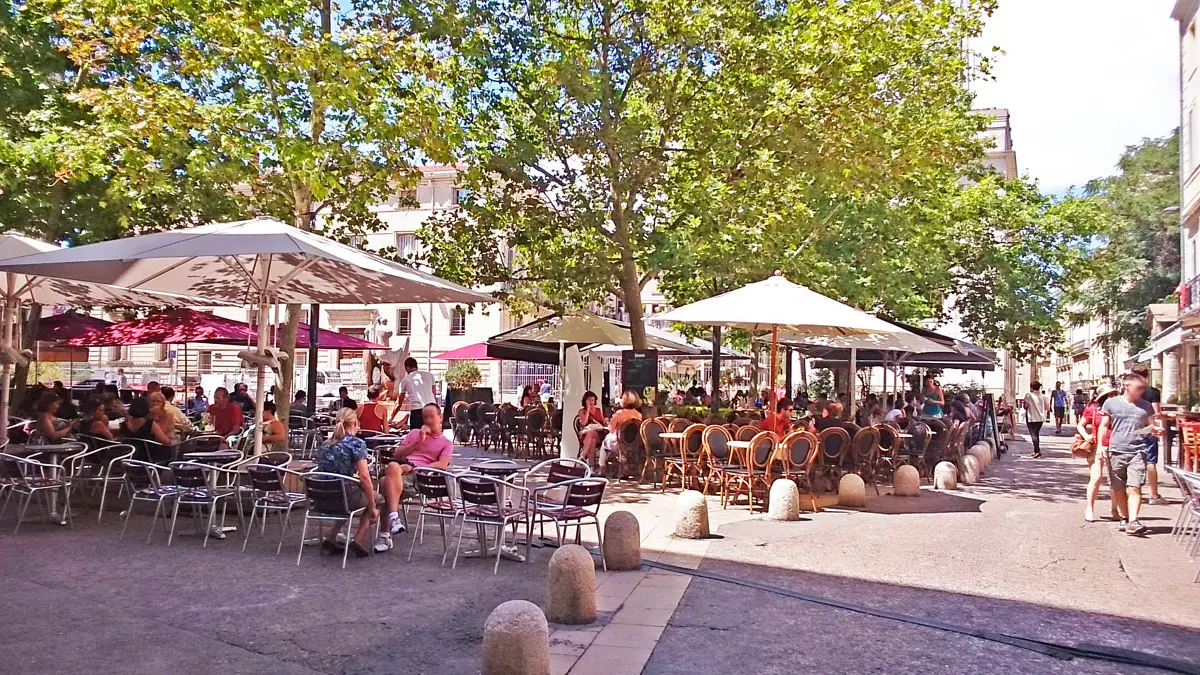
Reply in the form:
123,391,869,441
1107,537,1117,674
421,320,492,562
648,273,902,412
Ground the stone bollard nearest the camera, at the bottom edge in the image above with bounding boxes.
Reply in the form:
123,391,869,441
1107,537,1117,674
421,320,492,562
482,601,550,675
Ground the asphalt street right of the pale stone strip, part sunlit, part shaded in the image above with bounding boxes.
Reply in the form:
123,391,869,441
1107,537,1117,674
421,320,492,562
643,435,1200,675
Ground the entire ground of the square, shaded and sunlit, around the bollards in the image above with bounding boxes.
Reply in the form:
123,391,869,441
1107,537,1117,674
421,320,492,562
0,427,1200,675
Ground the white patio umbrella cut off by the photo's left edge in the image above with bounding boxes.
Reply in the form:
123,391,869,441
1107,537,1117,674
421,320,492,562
0,233,216,441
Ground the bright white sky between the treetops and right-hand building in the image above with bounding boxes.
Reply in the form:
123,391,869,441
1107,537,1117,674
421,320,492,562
973,0,1180,192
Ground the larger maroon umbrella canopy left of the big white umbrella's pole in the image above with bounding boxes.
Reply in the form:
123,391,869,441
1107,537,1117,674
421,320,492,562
67,309,258,347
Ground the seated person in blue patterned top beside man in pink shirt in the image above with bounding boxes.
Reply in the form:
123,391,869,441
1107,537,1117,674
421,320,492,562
317,407,379,557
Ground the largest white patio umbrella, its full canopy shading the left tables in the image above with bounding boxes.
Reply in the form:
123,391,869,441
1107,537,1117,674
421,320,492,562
0,219,494,454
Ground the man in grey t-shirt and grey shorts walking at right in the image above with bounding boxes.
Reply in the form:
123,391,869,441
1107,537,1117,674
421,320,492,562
1096,374,1162,534
